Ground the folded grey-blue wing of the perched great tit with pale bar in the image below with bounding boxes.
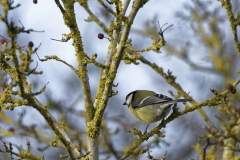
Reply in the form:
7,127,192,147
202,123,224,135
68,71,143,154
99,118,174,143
132,94,172,108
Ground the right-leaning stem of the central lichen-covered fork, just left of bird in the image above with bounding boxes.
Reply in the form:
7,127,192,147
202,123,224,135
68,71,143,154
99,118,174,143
89,0,142,137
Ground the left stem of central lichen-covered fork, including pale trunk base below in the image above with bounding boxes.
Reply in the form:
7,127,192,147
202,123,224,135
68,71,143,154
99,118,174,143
56,0,95,159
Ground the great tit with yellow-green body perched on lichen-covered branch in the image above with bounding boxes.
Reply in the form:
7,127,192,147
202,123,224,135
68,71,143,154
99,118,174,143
123,90,190,133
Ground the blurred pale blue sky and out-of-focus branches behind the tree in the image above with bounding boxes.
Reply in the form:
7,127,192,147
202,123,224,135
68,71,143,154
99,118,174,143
0,0,240,160
